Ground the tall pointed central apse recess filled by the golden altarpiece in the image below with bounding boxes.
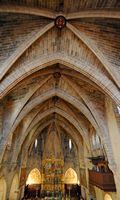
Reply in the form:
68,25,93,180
41,124,64,197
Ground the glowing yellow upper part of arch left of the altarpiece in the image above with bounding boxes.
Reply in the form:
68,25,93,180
26,168,41,185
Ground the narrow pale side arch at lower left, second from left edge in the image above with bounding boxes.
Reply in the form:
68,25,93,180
10,174,19,200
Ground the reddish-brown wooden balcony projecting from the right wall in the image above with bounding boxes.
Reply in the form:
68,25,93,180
89,170,116,192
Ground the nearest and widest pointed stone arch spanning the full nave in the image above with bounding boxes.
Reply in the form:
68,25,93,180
0,53,120,104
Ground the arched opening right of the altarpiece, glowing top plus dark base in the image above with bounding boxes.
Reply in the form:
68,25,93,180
64,168,81,199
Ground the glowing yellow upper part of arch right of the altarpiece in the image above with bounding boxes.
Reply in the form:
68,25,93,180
64,168,78,184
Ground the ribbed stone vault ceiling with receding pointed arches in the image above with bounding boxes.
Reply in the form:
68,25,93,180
0,0,120,172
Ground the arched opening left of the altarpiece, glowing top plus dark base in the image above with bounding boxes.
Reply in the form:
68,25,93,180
24,168,41,198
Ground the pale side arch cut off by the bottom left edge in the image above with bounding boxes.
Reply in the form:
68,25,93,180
0,178,7,200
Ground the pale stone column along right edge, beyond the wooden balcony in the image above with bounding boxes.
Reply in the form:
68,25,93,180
105,98,120,200
